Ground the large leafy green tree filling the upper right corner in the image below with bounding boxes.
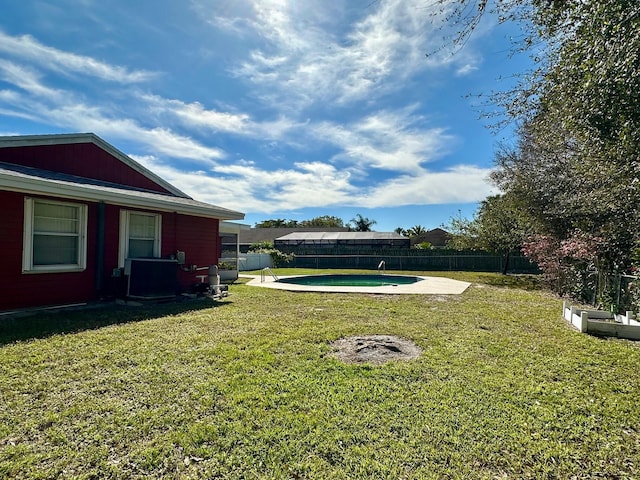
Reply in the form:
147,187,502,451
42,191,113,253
438,0,640,304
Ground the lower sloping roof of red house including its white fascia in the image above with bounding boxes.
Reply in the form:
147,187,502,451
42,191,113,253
0,162,244,220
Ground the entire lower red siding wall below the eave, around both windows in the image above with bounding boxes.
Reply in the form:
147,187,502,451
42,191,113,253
0,191,221,310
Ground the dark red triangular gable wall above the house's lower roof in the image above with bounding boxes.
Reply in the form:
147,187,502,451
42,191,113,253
0,143,170,193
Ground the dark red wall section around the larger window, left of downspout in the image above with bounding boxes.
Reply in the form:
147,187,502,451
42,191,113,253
0,191,96,310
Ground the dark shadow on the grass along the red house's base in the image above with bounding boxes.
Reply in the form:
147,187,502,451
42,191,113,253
0,298,232,347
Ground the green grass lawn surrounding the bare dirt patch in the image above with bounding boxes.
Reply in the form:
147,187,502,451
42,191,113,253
0,270,640,479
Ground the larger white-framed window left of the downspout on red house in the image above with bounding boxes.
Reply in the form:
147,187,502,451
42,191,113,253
22,198,87,272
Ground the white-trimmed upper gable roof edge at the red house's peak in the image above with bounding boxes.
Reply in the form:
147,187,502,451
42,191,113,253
0,133,191,198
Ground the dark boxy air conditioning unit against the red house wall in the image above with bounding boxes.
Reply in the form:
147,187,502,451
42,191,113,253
124,258,179,300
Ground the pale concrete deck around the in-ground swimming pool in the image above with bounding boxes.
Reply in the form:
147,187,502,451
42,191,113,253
241,275,471,295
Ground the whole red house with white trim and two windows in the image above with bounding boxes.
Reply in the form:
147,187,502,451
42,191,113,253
0,133,244,311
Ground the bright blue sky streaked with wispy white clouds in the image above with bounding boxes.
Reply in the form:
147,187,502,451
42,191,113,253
0,0,527,231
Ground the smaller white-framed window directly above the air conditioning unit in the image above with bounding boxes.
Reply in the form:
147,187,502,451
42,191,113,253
119,210,162,267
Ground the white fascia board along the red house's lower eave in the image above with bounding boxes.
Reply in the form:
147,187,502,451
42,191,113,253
0,172,244,220
